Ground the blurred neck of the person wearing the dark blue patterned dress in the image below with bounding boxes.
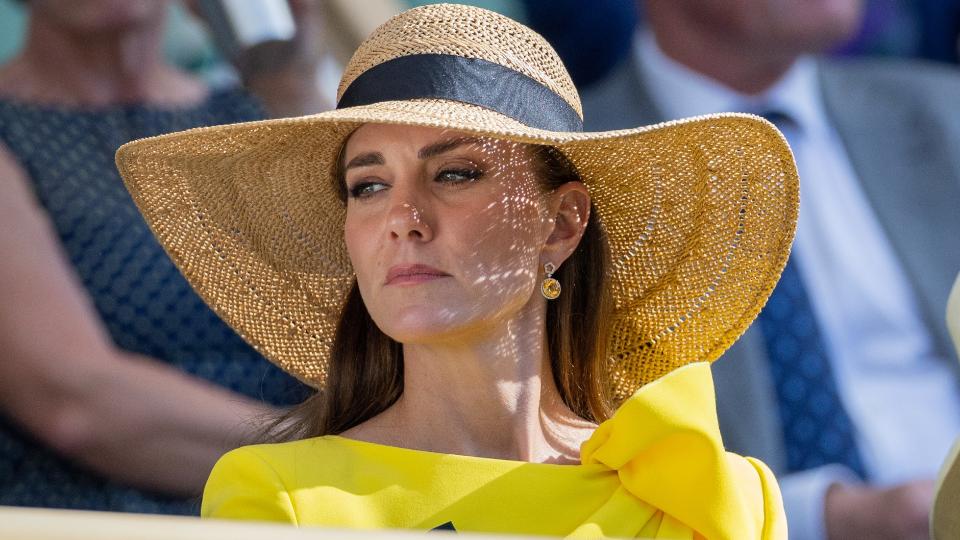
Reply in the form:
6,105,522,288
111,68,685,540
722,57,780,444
2,10,204,107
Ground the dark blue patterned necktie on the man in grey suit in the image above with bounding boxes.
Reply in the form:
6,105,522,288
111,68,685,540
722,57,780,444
757,108,866,478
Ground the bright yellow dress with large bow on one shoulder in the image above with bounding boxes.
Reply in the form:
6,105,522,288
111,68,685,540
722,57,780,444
201,363,787,540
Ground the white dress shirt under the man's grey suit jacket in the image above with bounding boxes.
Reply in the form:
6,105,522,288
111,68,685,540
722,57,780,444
635,31,960,540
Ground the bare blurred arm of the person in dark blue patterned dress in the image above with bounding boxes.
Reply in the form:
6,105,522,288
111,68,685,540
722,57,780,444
0,147,276,495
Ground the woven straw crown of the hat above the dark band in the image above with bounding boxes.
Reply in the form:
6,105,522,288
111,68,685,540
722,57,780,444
337,4,583,119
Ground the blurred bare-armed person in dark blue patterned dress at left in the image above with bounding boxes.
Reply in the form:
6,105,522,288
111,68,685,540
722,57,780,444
0,0,344,513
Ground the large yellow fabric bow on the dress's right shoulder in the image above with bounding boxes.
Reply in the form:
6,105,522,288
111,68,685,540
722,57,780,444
574,362,787,540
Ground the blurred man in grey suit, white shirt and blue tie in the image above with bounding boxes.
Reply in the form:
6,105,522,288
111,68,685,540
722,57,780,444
584,0,960,539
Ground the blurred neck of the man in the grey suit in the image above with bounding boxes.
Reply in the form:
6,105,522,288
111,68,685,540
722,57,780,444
650,14,798,95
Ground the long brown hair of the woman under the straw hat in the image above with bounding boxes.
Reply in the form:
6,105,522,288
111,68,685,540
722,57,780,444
267,141,613,441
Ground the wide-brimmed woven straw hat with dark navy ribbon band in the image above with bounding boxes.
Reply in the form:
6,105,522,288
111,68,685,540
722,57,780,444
117,4,798,399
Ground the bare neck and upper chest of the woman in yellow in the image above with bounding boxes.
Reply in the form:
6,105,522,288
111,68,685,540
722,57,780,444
347,304,595,463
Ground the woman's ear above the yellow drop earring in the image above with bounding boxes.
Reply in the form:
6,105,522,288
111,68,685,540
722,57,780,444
540,182,590,267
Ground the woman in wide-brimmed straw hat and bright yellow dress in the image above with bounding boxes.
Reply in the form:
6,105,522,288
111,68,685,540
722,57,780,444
117,5,797,539
